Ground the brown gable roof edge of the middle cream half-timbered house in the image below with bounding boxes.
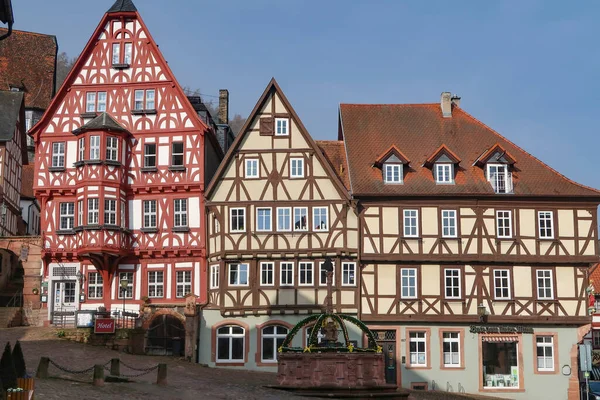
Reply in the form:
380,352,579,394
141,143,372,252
206,78,350,199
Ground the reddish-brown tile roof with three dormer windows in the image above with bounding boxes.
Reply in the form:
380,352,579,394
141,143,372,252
340,103,600,199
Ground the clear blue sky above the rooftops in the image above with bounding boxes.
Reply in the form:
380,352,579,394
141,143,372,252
13,0,600,188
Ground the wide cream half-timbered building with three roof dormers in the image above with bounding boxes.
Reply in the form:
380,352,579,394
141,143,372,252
339,93,600,399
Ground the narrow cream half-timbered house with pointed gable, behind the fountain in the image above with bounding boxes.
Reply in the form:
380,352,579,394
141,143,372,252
204,79,359,368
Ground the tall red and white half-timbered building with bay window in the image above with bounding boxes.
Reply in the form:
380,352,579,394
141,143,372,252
32,0,222,350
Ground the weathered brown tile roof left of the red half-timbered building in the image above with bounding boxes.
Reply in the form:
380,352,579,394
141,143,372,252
0,28,58,110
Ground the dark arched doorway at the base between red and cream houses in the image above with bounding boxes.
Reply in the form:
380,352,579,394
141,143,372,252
146,314,185,357
